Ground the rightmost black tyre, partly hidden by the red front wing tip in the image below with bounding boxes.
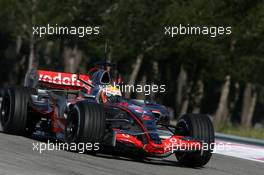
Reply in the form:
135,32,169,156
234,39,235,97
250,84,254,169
175,114,215,167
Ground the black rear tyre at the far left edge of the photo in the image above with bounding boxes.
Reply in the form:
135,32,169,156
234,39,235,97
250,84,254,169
0,87,30,135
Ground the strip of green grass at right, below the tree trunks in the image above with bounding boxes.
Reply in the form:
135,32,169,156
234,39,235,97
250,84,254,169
217,125,264,139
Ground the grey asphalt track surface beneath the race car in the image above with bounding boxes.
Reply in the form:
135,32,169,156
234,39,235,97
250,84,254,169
0,133,264,175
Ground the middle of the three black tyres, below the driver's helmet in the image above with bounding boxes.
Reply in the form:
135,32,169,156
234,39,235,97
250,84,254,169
65,101,105,152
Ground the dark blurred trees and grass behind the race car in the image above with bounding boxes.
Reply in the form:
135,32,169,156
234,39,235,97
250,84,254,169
0,0,264,138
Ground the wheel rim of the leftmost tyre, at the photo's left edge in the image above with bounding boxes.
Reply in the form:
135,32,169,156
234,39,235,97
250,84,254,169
1,95,11,126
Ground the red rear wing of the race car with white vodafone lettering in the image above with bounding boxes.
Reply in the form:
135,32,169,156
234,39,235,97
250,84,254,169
38,70,92,92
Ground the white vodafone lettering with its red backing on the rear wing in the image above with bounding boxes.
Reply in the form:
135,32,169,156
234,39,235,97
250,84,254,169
38,71,89,86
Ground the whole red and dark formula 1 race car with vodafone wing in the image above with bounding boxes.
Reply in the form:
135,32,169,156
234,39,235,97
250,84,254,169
0,62,214,167
